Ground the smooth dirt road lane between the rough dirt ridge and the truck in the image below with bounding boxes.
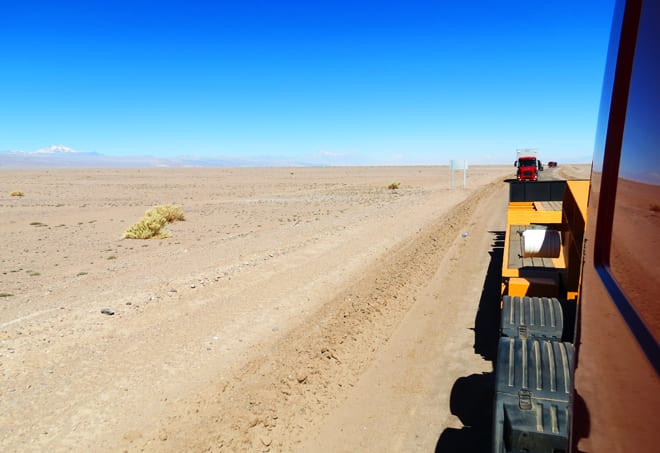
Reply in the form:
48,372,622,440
299,177,508,452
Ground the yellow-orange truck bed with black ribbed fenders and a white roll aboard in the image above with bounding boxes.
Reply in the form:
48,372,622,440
493,181,589,453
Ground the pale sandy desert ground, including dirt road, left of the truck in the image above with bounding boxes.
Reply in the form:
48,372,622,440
0,166,588,452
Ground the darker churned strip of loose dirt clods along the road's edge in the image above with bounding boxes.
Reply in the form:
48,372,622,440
142,180,501,451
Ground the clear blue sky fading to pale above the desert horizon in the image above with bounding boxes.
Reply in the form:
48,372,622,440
0,0,614,165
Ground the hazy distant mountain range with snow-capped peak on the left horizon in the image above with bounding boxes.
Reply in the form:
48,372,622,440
0,145,318,169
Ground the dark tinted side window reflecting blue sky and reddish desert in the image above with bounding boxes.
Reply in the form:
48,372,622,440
610,2,660,339
